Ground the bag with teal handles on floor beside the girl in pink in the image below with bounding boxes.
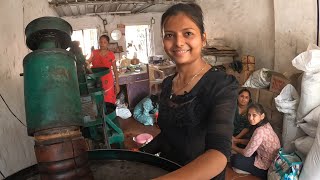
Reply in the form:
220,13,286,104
268,149,302,180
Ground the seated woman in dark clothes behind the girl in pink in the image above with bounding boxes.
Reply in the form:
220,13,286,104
232,89,251,141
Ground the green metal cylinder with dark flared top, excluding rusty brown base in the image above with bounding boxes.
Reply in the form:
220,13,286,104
23,17,83,135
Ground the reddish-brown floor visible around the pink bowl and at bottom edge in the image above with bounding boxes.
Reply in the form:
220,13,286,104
119,118,259,180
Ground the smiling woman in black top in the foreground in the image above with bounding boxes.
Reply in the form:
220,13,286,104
141,4,238,180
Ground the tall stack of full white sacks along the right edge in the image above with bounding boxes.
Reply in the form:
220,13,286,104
292,46,320,180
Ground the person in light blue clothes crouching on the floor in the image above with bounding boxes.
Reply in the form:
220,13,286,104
133,95,158,126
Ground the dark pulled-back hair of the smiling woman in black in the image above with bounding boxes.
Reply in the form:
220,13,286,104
161,3,205,34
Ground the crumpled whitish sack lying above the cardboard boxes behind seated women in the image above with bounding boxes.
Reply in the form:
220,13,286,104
242,68,270,88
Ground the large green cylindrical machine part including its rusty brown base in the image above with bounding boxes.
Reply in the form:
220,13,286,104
23,17,93,179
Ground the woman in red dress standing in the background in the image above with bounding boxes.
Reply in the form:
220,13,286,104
86,35,120,104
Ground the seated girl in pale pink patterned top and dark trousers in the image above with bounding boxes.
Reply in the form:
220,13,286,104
231,104,280,179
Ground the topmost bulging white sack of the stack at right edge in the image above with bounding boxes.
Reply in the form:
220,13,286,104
292,50,320,122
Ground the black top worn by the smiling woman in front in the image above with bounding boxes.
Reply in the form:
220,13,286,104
141,68,238,179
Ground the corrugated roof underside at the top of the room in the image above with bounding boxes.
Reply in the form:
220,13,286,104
48,0,195,17
